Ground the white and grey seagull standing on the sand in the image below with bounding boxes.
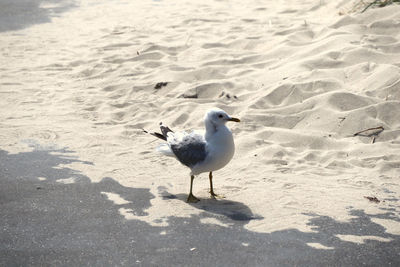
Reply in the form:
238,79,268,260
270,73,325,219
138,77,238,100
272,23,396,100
144,108,240,203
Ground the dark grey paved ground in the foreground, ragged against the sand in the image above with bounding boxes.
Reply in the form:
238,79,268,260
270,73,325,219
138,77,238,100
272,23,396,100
0,147,400,266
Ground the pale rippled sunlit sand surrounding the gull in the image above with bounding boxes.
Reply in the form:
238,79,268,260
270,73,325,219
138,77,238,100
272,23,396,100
0,0,400,264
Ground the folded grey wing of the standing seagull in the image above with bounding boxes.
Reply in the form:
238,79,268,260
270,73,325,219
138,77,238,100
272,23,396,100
169,133,207,168
